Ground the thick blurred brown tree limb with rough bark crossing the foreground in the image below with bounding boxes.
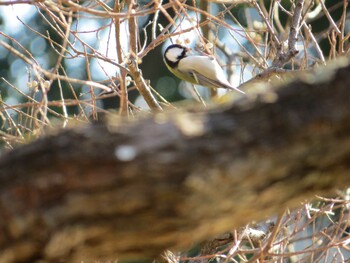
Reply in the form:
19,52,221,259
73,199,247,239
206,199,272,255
0,58,350,263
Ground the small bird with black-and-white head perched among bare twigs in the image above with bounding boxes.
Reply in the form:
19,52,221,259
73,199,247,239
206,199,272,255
164,44,244,94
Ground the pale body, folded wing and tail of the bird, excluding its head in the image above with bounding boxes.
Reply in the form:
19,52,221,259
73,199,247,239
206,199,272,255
178,56,244,93
